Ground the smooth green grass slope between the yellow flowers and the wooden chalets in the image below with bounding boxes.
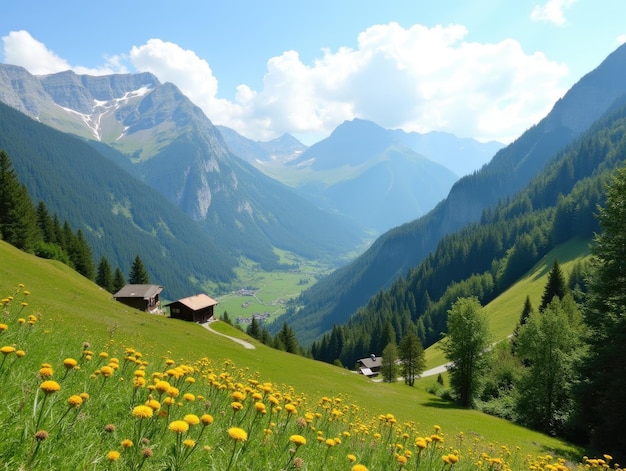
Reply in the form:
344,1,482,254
0,242,600,469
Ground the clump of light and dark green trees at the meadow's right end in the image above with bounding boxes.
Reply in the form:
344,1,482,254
438,167,626,459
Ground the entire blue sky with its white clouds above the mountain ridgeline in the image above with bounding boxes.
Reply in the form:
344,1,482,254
0,0,626,144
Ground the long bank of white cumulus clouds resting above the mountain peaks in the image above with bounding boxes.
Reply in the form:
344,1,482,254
3,23,568,143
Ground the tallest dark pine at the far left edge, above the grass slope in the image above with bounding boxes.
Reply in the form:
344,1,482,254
0,151,41,252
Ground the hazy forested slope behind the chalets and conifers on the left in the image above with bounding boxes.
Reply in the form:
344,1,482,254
0,103,234,298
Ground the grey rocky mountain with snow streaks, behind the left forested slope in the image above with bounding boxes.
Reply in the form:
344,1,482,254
0,65,361,269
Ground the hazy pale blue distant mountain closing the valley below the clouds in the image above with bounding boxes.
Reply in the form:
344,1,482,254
219,119,472,234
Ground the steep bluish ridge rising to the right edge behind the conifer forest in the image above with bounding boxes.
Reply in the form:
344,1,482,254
282,42,626,341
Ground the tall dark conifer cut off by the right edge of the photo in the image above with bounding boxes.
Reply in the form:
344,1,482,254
578,167,626,460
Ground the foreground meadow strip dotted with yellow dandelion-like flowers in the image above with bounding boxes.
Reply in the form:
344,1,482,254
0,285,620,471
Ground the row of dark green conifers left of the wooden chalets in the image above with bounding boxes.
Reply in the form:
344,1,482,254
0,150,149,293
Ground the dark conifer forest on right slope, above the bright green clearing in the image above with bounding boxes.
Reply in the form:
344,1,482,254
312,97,626,366
